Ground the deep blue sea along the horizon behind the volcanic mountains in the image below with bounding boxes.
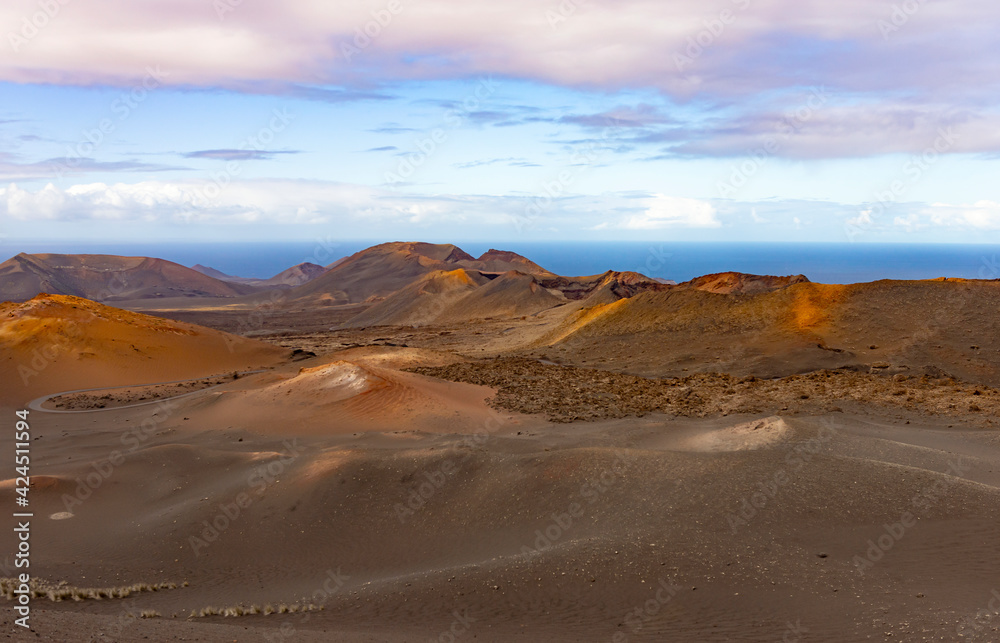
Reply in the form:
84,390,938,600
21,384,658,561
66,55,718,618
0,240,1000,283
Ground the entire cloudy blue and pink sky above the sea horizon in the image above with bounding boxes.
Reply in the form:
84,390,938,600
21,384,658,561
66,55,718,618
0,0,1000,245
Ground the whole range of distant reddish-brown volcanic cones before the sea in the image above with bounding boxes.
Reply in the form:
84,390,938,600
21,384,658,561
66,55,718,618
0,247,809,336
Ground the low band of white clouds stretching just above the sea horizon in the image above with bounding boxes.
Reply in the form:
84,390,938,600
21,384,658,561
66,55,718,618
0,180,1000,241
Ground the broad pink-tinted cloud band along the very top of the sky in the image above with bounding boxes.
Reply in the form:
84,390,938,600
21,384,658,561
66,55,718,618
0,0,1000,102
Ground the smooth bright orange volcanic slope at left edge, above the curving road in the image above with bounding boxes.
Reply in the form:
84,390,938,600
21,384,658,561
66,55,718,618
0,294,288,404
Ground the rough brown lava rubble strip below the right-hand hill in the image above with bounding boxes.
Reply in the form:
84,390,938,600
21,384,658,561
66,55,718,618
413,358,1000,426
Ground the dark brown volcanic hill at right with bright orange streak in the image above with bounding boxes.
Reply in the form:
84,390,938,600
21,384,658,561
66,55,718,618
536,277,1000,384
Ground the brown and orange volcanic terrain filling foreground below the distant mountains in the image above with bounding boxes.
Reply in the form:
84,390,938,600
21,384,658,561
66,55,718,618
0,248,1000,643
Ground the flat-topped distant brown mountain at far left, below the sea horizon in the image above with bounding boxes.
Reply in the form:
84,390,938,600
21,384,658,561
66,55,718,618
0,253,255,301
